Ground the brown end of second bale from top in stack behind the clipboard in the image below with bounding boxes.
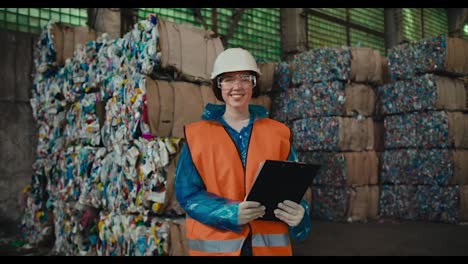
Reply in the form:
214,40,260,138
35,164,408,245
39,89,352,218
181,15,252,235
343,83,375,116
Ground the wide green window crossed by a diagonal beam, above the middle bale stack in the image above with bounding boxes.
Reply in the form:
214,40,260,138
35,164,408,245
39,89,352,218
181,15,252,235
307,8,385,55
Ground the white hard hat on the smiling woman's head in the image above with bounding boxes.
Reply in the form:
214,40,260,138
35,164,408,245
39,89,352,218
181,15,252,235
211,48,262,79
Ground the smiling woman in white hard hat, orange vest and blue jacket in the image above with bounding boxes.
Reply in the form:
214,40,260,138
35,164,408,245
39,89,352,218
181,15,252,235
174,48,310,256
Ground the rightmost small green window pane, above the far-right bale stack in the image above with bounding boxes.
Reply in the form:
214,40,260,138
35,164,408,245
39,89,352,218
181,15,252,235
423,8,448,37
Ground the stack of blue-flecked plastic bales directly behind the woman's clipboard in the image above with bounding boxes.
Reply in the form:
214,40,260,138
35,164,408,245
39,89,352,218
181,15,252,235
272,47,385,221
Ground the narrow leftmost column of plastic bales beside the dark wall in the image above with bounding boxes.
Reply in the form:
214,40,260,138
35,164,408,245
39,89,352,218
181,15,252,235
21,23,72,248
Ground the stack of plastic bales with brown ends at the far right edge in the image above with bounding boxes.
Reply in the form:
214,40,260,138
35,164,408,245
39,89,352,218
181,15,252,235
378,36,468,223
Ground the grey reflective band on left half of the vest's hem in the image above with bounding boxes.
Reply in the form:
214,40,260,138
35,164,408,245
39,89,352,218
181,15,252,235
188,238,244,253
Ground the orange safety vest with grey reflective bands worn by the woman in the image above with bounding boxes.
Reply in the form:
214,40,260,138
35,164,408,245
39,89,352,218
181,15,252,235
185,118,292,256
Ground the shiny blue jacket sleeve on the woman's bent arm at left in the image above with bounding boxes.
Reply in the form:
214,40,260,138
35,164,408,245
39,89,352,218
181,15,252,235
174,144,241,232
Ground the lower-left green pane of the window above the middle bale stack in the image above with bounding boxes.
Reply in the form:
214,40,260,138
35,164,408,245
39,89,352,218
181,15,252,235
307,16,346,48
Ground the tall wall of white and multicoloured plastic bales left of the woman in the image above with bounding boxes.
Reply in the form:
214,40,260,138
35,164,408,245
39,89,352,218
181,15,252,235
24,16,183,255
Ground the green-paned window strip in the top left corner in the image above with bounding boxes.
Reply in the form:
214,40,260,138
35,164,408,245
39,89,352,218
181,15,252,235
0,8,88,33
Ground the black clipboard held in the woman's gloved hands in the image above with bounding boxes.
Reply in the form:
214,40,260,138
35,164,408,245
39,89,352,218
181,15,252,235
245,160,320,221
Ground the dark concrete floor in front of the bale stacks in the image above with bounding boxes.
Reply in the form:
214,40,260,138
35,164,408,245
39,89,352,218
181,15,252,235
0,220,468,256
